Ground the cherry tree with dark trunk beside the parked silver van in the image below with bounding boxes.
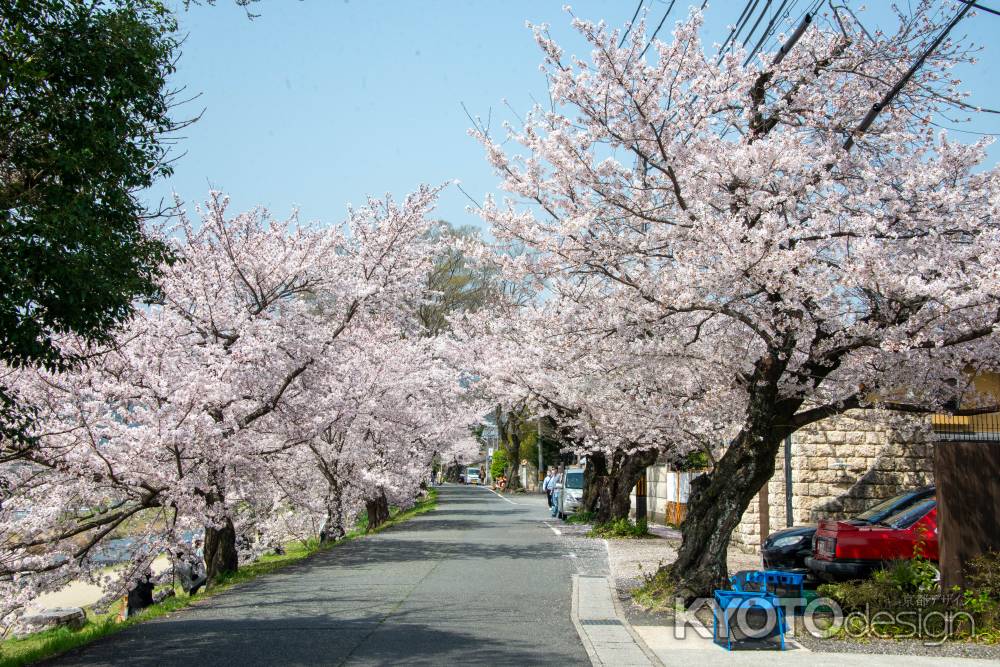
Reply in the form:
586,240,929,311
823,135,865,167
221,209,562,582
466,297,720,523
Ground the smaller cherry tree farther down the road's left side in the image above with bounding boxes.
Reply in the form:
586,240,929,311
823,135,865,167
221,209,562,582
264,322,480,541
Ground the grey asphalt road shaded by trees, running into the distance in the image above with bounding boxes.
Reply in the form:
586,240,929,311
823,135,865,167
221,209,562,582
53,486,590,667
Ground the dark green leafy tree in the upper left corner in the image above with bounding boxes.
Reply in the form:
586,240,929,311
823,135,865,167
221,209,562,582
0,0,179,444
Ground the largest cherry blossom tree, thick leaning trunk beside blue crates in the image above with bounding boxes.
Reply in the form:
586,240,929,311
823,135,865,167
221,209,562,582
472,2,1000,598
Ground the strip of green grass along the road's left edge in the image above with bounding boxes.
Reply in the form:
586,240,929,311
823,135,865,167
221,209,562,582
0,488,438,667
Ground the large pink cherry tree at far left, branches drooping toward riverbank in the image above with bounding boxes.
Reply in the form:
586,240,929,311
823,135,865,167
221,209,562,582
0,187,443,615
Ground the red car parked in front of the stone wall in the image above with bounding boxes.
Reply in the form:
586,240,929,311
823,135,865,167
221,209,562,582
806,497,938,581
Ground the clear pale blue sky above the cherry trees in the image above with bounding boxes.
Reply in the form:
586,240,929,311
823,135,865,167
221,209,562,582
147,0,1000,232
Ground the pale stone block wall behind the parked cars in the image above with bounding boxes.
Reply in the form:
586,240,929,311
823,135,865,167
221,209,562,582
733,410,933,551
